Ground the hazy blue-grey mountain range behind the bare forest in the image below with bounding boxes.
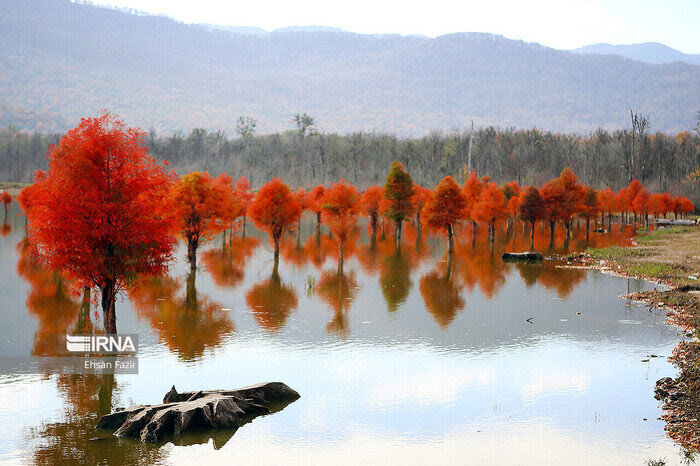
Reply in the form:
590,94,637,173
0,0,700,135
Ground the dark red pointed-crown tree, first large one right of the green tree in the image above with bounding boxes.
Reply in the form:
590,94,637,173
423,176,467,254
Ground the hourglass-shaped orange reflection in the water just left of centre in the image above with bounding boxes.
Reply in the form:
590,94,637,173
316,271,357,338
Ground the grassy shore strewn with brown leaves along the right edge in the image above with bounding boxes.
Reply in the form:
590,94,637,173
584,226,700,452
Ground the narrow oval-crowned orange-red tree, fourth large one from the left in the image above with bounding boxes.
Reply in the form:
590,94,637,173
322,180,360,273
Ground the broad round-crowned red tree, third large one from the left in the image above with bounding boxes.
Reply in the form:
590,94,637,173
248,178,301,262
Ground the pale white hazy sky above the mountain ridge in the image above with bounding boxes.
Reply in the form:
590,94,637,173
93,0,700,53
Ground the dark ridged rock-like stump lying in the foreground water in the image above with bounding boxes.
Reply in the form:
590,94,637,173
97,382,299,442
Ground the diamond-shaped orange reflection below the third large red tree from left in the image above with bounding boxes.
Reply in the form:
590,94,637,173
245,265,298,333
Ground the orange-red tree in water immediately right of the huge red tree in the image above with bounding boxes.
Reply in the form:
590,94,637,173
172,172,235,269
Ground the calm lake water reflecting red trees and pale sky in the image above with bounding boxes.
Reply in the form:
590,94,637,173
0,210,692,465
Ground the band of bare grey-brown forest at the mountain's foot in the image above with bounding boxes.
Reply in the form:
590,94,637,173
0,119,700,204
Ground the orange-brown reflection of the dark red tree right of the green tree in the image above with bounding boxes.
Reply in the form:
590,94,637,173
418,261,465,328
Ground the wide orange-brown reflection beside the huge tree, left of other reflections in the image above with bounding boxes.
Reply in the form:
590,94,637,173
129,271,234,361
